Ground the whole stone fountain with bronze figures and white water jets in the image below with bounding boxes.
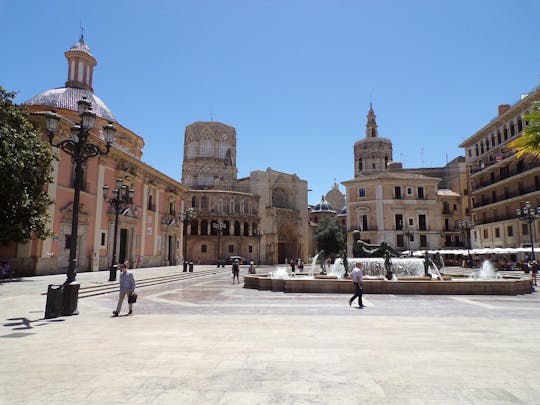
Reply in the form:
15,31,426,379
244,243,533,295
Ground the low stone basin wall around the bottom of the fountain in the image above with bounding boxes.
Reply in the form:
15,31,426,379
244,275,533,295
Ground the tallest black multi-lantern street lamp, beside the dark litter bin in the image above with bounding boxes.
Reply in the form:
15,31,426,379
45,97,116,315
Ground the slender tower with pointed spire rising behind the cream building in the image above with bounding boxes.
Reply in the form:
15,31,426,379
354,103,392,177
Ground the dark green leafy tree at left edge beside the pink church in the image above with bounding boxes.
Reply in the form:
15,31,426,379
0,86,54,244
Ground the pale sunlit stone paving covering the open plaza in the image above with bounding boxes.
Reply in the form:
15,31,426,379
0,266,540,404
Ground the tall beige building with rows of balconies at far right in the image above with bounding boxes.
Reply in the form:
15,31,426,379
459,88,540,248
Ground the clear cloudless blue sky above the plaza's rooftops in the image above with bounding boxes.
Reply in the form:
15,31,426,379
0,0,540,203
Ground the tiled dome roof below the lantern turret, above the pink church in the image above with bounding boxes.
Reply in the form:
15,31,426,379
24,87,117,123
